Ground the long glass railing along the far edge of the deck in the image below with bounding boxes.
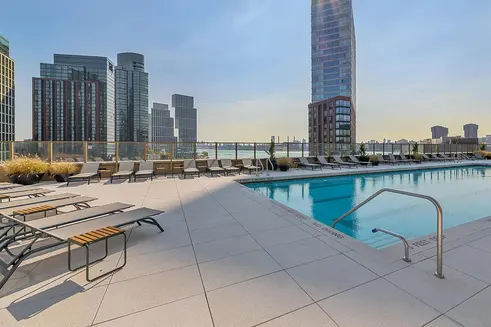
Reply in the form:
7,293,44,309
0,141,482,162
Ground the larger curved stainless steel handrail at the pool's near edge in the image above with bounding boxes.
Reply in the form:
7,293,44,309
332,188,445,278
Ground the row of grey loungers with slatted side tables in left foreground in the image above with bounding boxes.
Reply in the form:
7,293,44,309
0,193,164,289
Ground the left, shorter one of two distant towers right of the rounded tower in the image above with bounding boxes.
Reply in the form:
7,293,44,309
154,102,177,148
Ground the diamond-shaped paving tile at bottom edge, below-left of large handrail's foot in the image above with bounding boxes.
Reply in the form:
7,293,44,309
319,278,440,327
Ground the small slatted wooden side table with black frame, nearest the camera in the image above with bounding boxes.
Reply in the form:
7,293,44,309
68,226,126,282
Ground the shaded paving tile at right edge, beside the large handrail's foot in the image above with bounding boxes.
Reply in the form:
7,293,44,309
443,245,491,283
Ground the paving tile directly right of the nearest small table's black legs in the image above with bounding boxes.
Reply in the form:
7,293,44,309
111,246,196,283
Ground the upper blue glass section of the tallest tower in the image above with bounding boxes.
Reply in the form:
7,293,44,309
311,0,356,103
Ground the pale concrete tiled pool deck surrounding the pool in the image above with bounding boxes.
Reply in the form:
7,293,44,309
0,161,491,327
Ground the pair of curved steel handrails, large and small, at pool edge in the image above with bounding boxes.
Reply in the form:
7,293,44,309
332,188,445,278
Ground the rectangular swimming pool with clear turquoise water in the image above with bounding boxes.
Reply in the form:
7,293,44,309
246,166,491,248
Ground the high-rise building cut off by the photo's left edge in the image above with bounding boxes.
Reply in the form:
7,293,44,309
0,35,15,160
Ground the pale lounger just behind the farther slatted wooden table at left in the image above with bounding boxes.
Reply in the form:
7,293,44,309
0,196,97,220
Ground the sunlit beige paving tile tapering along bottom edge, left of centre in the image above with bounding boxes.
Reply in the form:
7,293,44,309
97,294,213,327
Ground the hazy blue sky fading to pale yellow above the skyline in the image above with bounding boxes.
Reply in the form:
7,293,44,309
0,0,491,142
